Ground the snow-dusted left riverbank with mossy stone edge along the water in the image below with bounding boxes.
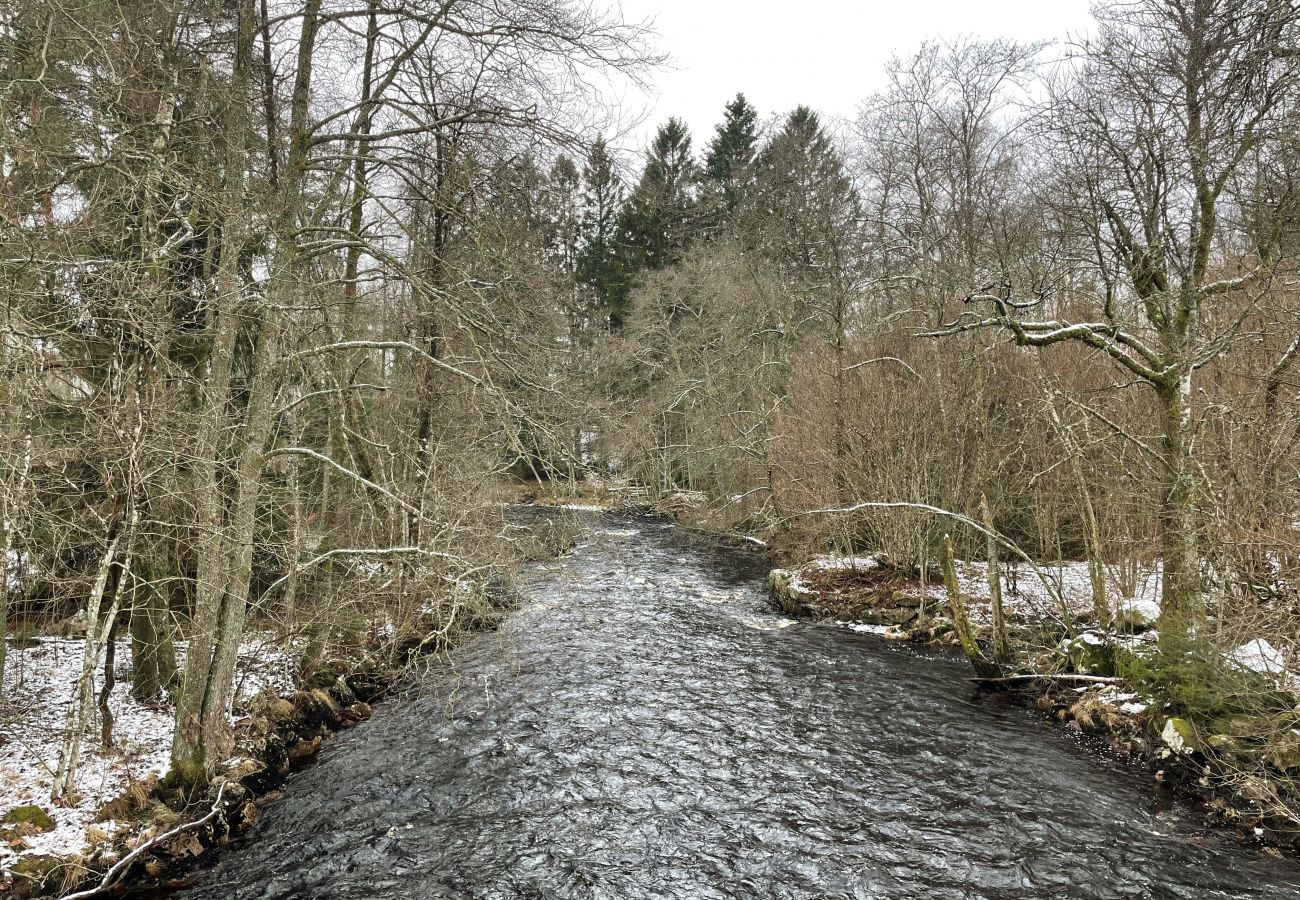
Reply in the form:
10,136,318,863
0,543,553,897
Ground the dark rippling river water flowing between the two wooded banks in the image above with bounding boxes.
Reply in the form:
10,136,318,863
172,516,1300,900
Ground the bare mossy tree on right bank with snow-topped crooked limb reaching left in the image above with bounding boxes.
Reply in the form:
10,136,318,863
935,0,1296,649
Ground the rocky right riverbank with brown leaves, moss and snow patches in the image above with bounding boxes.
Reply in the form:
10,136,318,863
768,555,1300,852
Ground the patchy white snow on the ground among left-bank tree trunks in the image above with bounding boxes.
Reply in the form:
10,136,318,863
0,632,293,870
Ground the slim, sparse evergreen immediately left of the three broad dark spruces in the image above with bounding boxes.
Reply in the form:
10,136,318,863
576,138,624,328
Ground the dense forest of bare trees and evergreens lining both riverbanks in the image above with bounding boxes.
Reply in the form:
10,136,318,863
0,0,1300,894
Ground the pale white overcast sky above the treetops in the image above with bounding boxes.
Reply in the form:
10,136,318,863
621,0,1089,150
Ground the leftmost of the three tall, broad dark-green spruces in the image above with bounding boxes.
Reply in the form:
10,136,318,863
620,118,699,293
